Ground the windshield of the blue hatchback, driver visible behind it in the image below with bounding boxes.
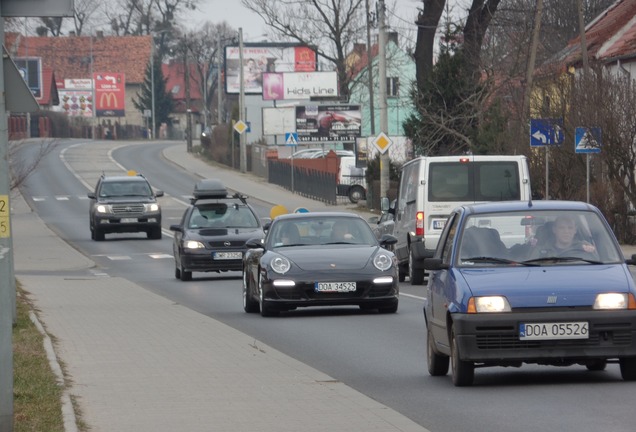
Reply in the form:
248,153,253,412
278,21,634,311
455,210,624,267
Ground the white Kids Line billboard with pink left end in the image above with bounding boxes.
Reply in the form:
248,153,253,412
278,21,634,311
263,71,338,100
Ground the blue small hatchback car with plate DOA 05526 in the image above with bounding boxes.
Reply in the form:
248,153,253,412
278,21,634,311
424,201,636,386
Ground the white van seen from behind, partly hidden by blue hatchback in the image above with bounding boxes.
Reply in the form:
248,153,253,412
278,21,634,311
383,155,531,285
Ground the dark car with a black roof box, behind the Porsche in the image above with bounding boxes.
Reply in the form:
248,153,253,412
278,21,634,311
170,179,265,281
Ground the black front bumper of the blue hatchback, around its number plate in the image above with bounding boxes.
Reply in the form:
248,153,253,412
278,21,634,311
453,310,636,363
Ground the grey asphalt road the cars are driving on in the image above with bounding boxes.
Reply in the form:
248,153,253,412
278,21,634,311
17,141,636,432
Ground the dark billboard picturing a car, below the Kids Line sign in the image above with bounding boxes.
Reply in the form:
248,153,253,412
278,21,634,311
296,105,362,143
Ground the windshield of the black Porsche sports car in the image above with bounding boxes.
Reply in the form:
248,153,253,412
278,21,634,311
268,216,378,247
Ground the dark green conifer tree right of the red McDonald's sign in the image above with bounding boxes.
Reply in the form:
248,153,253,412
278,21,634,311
133,56,174,136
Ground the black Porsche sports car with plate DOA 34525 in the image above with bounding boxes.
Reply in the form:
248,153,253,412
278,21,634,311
243,212,399,316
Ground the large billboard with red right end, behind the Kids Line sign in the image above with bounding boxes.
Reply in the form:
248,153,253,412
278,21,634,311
225,45,316,94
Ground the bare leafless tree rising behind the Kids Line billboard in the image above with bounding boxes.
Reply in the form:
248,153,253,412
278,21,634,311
241,0,366,100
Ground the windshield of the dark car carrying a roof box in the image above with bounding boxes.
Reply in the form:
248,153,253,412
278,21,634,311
189,203,259,228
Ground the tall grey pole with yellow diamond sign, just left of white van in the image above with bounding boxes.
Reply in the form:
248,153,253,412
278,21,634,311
378,0,391,197
